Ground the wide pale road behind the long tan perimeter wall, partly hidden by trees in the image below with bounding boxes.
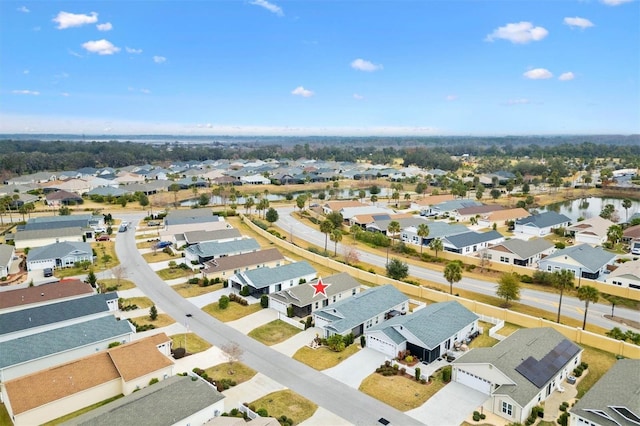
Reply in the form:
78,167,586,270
276,207,640,329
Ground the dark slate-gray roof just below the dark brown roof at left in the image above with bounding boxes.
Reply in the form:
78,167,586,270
0,293,112,336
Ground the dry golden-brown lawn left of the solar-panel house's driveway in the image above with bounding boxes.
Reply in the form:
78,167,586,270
360,373,445,411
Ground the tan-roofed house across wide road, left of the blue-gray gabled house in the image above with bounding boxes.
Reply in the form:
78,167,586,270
487,238,555,267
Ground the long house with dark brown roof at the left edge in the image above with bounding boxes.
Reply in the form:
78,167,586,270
0,279,94,313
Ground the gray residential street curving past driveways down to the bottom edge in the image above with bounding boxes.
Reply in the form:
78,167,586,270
116,215,422,425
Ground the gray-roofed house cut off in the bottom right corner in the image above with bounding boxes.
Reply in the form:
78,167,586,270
568,359,640,426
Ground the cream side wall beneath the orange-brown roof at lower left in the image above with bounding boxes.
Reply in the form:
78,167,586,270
3,378,122,426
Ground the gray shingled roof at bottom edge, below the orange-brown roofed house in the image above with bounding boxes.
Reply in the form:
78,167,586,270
63,376,224,426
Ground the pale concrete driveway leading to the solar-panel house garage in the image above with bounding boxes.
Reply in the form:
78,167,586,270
405,382,489,426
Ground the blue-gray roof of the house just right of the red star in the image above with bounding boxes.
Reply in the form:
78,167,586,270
315,284,409,334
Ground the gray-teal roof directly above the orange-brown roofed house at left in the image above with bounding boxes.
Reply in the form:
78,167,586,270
0,315,134,368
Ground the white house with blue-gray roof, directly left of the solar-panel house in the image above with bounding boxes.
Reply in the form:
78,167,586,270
364,301,478,363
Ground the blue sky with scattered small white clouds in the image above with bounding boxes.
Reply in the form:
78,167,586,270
0,0,640,135
